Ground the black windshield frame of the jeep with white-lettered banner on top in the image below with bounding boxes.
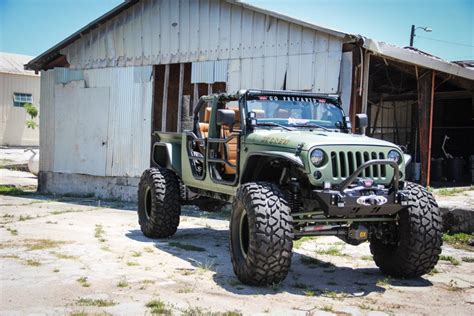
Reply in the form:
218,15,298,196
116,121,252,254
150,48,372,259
240,91,348,133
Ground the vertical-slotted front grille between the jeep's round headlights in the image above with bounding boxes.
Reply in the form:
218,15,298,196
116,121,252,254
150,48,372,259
330,151,387,179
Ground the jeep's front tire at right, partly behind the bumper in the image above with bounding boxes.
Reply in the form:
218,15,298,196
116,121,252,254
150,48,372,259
370,183,443,278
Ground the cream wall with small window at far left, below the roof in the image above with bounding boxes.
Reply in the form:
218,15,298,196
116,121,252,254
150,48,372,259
0,73,40,146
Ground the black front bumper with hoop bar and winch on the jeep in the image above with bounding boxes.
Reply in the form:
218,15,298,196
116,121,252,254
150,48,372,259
311,160,408,217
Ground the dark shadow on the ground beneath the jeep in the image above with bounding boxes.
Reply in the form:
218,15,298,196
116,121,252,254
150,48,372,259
126,227,432,298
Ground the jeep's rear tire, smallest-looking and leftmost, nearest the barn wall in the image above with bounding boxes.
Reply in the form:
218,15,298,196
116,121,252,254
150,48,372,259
138,168,181,238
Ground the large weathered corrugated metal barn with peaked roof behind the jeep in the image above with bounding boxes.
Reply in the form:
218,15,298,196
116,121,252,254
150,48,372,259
26,0,474,199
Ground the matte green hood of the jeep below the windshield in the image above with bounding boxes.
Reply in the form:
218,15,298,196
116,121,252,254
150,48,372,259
246,129,398,150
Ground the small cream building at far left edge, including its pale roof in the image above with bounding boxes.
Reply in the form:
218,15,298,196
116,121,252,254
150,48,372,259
0,53,40,146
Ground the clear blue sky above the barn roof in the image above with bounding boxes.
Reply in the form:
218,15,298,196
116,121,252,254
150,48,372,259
0,0,474,60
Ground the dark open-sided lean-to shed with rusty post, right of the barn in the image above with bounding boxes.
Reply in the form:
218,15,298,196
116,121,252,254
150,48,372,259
344,38,474,185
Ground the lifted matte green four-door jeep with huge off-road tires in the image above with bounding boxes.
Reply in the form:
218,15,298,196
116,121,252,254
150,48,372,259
138,90,442,285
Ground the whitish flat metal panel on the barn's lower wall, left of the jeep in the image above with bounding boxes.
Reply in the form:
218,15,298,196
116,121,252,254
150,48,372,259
41,66,152,177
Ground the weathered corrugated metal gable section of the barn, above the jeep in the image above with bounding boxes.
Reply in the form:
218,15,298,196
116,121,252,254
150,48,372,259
62,0,342,93
